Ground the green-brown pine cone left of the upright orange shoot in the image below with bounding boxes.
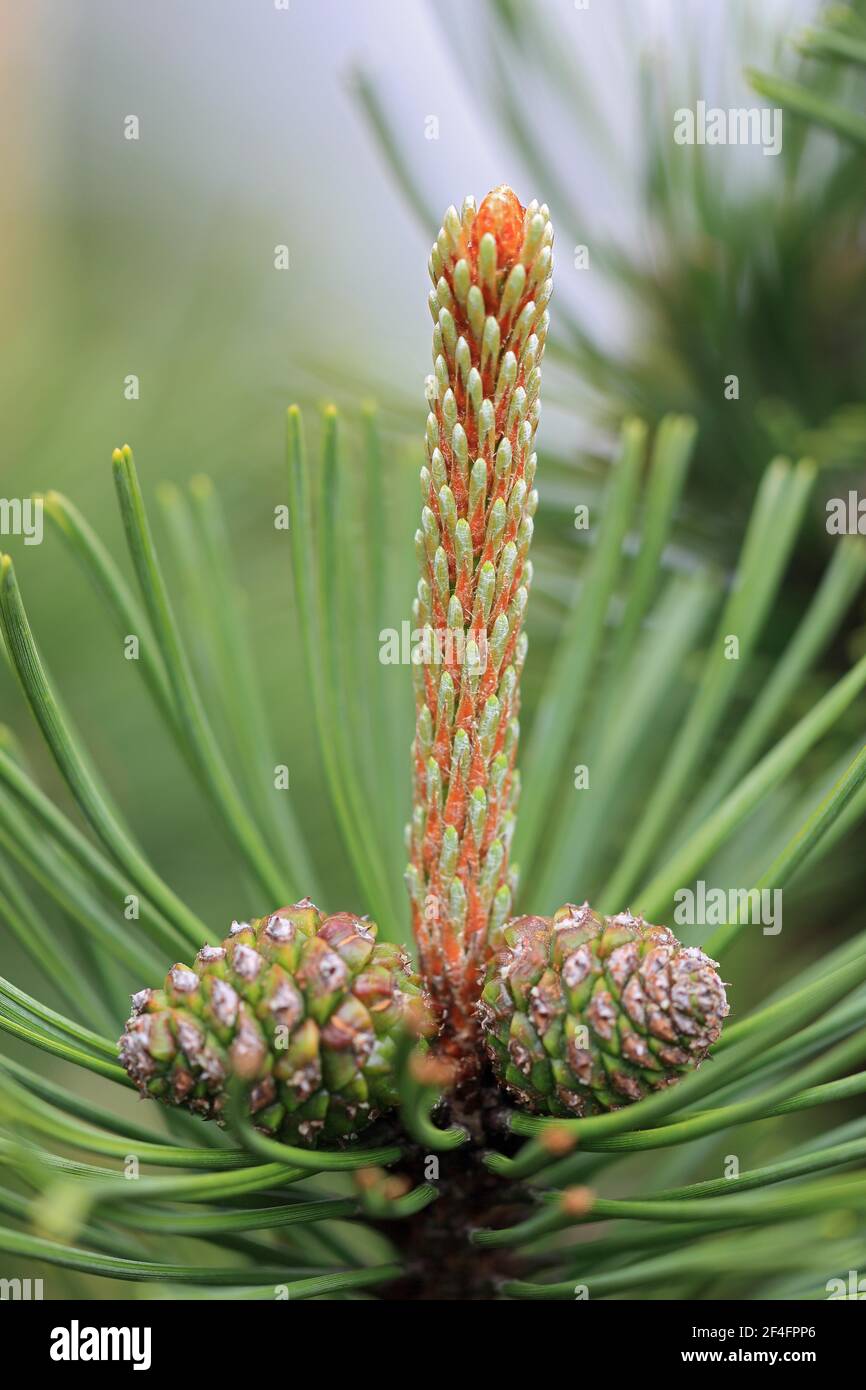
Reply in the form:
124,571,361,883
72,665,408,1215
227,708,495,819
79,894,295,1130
120,899,431,1147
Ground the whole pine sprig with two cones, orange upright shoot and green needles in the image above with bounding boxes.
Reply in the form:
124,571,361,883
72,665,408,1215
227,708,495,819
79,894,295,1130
0,162,866,1301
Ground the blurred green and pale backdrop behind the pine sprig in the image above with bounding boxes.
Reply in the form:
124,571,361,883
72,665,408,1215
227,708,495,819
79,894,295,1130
0,0,866,1301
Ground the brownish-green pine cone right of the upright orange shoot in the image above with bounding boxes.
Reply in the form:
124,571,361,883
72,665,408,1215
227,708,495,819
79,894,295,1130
478,904,728,1116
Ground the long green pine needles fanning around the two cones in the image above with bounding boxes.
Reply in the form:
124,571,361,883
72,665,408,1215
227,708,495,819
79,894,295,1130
0,397,866,1300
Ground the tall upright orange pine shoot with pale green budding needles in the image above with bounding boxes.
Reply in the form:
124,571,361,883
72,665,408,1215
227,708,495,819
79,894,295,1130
407,188,553,1050
